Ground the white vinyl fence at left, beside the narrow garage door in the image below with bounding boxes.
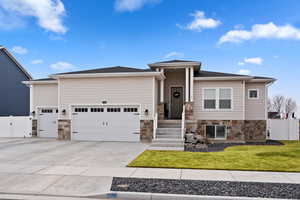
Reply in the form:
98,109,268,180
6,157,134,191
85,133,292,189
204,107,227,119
0,116,32,137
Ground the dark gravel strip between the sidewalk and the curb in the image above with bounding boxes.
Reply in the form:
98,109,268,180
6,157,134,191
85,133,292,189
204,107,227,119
111,177,300,199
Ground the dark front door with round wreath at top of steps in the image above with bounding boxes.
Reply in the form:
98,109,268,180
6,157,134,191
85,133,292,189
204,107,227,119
171,87,184,119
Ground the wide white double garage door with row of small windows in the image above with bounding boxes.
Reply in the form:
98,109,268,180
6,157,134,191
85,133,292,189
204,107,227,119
72,105,140,141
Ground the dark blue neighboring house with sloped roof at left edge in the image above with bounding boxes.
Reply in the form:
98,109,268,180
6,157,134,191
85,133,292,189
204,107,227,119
0,46,32,116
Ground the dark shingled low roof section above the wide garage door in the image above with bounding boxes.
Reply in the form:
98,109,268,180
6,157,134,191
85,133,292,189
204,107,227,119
54,66,153,75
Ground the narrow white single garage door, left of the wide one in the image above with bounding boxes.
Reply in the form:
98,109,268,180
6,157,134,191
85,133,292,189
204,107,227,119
38,108,58,138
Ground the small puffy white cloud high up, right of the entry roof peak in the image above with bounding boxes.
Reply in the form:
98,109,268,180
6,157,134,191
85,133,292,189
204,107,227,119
177,10,221,31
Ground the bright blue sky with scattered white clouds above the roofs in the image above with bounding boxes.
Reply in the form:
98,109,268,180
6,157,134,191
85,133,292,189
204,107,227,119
0,0,300,115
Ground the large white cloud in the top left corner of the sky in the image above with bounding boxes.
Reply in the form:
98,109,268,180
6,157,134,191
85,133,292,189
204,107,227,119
0,0,67,34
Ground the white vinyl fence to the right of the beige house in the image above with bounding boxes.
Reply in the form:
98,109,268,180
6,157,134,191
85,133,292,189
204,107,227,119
268,119,299,140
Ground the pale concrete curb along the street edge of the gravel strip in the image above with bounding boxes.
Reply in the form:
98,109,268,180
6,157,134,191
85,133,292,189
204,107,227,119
88,191,278,200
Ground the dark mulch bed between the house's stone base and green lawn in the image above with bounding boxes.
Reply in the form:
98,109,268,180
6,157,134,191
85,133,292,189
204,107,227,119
184,140,284,152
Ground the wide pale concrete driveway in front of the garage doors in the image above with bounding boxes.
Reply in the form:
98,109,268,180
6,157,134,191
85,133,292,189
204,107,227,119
0,138,147,196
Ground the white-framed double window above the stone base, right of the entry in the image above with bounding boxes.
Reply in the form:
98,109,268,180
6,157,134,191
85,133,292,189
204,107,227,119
203,88,232,110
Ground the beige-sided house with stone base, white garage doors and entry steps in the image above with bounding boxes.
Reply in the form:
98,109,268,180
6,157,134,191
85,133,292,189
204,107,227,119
25,60,275,142
